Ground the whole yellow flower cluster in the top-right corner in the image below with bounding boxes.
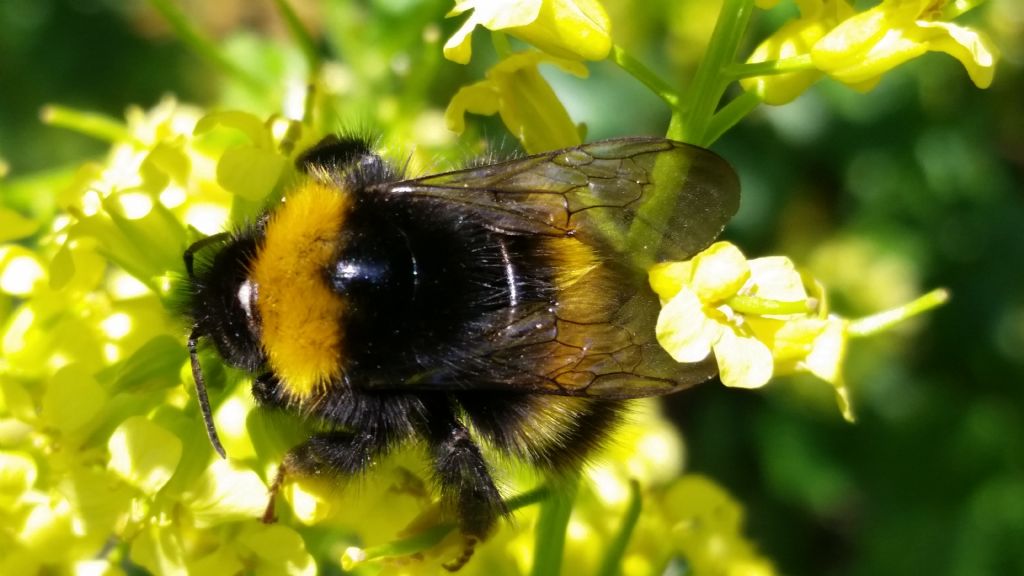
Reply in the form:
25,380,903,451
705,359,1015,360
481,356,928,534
742,0,996,105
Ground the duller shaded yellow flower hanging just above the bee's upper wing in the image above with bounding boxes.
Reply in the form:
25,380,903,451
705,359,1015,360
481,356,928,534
444,51,587,153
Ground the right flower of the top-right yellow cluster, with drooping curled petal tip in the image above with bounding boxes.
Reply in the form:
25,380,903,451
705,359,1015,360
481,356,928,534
811,0,996,89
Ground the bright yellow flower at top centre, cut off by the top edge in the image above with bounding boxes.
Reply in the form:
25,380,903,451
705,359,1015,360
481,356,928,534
444,0,611,64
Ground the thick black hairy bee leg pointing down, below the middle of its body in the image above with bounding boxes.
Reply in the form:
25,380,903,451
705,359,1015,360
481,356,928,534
427,403,508,541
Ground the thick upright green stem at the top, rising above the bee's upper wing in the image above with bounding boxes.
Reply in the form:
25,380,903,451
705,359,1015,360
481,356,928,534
669,0,754,146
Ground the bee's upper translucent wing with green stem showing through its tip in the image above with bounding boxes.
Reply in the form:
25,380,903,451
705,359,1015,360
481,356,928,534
387,137,739,259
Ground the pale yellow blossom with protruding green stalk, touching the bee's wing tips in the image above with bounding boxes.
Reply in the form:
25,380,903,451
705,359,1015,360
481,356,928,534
649,242,946,420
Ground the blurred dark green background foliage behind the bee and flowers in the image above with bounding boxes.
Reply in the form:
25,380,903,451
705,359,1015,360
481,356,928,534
0,0,1024,575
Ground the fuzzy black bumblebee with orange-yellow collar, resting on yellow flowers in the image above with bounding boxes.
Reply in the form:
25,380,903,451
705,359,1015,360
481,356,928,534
184,136,739,557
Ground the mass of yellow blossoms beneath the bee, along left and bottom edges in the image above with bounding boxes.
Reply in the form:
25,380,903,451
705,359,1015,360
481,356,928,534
0,99,767,574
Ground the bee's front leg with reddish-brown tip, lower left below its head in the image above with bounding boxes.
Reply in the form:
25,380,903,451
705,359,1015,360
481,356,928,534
263,433,386,524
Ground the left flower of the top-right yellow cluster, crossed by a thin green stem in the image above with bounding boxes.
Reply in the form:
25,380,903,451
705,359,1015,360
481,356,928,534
740,0,853,106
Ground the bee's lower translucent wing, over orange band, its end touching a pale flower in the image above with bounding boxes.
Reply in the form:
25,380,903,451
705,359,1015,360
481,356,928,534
444,276,718,399
